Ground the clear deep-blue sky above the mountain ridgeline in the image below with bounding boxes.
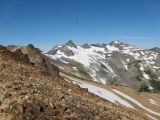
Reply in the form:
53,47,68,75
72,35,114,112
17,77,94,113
0,0,160,50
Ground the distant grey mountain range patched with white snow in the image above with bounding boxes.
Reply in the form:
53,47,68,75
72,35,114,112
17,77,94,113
45,40,160,91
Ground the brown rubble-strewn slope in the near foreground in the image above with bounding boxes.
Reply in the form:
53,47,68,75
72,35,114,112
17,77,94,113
0,46,149,120
